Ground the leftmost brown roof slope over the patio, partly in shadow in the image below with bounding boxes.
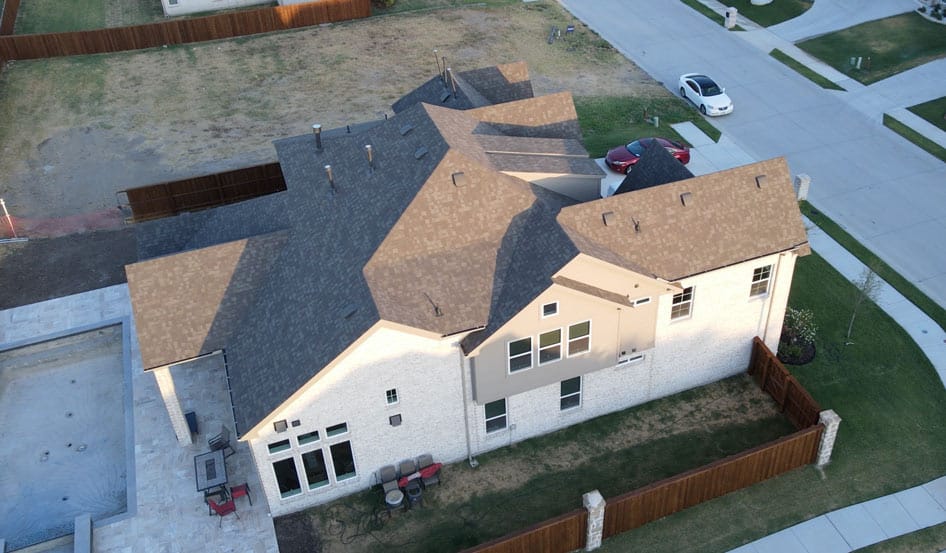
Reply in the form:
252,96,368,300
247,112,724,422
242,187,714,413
125,231,288,369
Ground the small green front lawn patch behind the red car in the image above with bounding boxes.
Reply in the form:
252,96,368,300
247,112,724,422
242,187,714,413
575,95,720,158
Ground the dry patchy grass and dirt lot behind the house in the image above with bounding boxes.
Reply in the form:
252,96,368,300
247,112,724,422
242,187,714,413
0,0,668,306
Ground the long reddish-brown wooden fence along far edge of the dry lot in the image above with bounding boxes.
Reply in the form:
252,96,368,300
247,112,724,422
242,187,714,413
0,0,371,60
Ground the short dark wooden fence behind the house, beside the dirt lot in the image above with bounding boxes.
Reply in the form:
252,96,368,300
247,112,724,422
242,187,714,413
119,163,286,222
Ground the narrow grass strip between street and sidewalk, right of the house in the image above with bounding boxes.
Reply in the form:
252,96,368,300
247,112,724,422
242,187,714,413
800,201,946,329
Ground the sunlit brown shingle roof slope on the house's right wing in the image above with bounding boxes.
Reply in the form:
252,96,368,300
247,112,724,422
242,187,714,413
558,158,808,281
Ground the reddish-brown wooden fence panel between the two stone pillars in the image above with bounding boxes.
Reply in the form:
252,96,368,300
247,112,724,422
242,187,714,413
603,425,823,538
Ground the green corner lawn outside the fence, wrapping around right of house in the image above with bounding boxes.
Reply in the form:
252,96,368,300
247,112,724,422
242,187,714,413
601,254,946,553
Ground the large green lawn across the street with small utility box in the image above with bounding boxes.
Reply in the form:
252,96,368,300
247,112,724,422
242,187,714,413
798,12,946,84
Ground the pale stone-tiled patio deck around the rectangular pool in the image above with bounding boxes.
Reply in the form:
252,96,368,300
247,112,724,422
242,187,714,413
0,285,278,553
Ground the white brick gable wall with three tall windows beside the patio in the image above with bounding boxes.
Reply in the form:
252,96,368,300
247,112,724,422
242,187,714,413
250,328,466,515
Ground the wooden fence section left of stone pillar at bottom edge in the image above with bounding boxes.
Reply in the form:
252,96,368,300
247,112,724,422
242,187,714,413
466,509,588,553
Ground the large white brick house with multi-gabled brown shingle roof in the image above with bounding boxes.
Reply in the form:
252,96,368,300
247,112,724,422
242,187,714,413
121,64,809,515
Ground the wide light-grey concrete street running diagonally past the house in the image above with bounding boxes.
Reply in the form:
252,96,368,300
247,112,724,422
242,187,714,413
560,0,946,305
